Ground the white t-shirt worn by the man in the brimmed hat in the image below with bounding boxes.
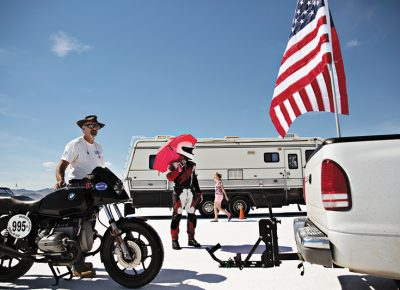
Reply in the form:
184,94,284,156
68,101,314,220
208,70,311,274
61,136,105,180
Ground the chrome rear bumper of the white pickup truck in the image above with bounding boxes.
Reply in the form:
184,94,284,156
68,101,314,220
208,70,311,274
293,217,333,267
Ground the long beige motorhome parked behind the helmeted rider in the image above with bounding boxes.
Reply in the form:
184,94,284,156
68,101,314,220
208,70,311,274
124,135,323,216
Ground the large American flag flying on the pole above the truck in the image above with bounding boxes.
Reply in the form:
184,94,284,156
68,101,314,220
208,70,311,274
269,0,349,137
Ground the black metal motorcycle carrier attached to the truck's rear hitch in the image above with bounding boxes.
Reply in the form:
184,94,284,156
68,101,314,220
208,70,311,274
206,205,304,275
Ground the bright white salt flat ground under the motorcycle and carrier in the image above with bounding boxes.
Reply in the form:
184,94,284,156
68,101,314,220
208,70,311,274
0,206,397,290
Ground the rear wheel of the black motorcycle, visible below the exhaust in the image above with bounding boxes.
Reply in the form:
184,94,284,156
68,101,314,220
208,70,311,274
0,255,33,282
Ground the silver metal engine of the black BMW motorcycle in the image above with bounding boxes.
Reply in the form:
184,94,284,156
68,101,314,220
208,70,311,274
37,219,94,253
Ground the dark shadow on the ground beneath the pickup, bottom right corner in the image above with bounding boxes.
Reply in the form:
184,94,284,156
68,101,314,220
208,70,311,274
338,275,398,290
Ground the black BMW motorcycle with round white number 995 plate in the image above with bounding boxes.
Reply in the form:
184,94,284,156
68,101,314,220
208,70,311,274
0,167,164,288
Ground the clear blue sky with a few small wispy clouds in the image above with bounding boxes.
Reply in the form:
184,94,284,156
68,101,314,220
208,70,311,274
0,0,400,189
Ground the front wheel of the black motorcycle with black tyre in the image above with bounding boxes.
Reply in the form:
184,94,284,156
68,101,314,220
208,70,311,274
101,222,164,288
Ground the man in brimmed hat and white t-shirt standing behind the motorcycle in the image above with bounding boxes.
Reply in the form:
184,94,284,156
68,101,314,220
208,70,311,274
54,115,105,278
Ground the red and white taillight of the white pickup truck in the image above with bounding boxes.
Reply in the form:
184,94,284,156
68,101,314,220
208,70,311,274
321,159,351,211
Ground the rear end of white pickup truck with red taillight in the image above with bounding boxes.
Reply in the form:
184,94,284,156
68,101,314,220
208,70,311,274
294,135,400,286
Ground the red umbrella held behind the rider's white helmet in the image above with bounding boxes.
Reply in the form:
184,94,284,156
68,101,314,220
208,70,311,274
153,134,197,172
